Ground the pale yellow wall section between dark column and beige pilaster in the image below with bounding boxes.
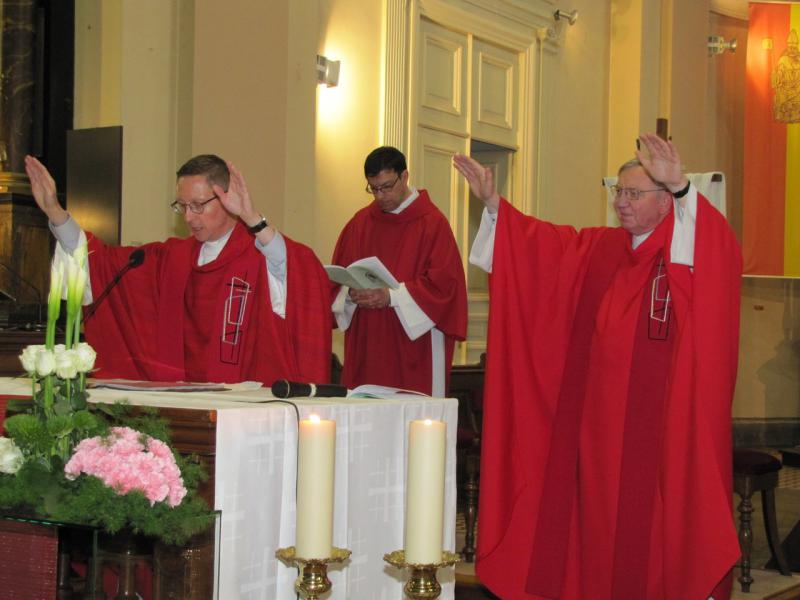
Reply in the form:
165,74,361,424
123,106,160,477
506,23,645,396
74,0,185,244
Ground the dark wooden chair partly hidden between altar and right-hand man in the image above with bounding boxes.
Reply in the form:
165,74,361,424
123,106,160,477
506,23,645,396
447,353,486,562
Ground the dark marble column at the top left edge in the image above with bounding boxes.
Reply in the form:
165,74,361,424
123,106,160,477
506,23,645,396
0,0,37,180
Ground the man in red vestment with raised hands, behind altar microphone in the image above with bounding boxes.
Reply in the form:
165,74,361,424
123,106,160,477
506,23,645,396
26,155,331,385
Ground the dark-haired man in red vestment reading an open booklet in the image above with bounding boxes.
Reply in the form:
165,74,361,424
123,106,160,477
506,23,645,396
333,146,467,397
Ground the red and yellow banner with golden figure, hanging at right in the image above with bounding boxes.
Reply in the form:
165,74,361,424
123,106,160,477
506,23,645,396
742,2,800,277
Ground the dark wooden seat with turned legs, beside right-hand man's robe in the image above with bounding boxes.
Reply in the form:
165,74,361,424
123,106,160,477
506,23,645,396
733,449,791,592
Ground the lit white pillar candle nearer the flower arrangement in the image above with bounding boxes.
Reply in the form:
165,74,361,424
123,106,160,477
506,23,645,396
295,415,336,558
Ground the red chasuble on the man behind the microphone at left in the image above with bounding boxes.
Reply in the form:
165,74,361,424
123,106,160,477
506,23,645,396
86,223,331,385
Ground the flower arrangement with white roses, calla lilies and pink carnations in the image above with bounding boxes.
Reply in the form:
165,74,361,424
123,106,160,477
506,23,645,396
0,239,213,544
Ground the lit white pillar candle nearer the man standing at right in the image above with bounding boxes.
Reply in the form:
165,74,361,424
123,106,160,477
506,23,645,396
405,419,447,564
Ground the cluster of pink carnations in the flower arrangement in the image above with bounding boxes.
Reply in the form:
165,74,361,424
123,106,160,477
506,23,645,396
64,427,186,507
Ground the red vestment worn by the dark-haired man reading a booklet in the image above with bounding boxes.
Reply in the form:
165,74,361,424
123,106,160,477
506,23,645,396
333,190,467,394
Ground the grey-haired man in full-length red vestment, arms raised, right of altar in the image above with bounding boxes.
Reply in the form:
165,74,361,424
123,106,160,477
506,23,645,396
454,134,741,600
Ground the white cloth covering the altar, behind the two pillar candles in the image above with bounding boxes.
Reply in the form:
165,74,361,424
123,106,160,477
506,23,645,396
0,378,458,600
